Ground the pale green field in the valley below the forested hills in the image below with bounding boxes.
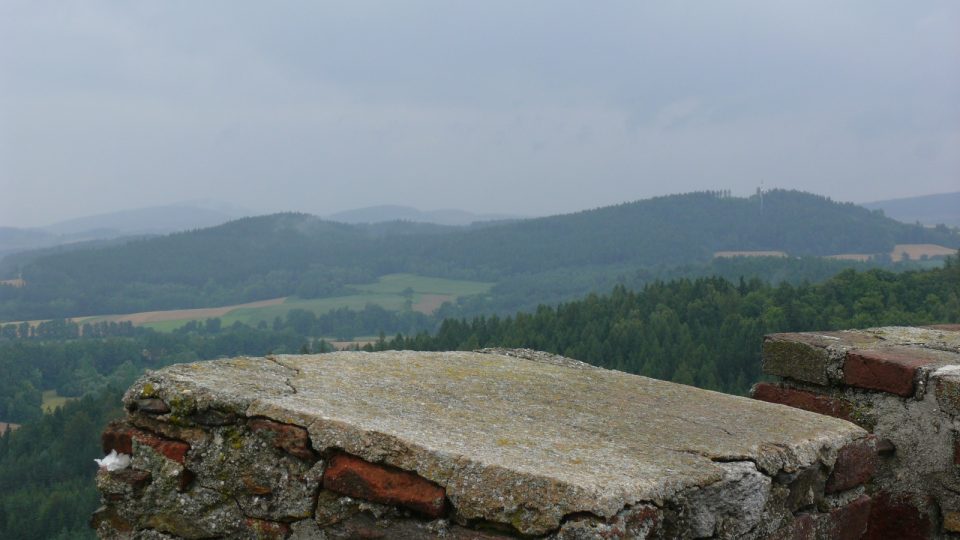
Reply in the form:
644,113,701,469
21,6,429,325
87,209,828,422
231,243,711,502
143,274,494,332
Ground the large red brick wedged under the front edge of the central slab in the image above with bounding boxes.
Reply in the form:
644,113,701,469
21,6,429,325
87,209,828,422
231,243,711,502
323,454,447,518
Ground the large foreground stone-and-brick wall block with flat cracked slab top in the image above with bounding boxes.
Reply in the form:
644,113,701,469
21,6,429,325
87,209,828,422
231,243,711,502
92,348,876,540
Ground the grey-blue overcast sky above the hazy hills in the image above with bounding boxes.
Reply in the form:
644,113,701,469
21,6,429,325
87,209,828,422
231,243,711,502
0,0,960,226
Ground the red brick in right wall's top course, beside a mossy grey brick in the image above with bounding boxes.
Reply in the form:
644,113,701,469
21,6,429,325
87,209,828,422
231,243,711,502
843,348,936,397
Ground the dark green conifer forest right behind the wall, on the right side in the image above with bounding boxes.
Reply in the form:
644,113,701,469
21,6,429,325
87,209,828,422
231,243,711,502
383,258,960,394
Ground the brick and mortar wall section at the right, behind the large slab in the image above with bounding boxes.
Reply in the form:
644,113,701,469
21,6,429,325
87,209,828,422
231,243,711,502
753,325,960,539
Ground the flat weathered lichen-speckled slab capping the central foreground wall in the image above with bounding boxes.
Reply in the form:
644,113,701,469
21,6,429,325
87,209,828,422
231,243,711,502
118,352,866,535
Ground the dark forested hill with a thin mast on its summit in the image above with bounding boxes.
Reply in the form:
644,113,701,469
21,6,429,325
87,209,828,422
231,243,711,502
414,190,960,273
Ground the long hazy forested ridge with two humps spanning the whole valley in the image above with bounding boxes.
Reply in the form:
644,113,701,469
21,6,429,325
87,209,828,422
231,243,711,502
0,191,960,320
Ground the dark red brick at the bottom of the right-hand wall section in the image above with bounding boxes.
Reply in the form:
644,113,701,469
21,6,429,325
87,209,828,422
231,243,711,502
863,492,933,540
